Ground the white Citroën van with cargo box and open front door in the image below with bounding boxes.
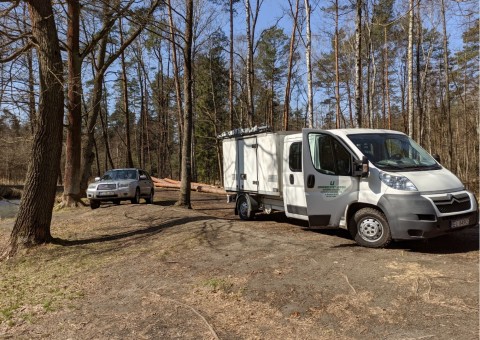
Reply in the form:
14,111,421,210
219,129,478,247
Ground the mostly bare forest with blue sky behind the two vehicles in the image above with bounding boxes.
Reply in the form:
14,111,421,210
0,0,480,194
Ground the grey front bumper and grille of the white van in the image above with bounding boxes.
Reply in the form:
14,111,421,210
379,191,479,240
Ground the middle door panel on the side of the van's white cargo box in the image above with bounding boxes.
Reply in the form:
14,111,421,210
238,137,258,192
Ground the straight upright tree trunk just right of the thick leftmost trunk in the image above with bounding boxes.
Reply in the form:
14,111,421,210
61,0,83,207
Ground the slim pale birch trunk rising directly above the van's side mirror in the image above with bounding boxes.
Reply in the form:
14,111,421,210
355,0,363,127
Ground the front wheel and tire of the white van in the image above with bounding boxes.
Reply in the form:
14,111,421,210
349,208,392,248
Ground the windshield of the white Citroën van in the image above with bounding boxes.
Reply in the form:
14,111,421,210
348,133,441,171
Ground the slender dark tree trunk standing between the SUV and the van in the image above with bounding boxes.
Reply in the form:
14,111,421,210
176,0,193,209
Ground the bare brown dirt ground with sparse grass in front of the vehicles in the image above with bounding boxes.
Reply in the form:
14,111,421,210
0,190,479,340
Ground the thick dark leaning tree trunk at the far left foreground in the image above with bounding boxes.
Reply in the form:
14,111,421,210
4,0,64,256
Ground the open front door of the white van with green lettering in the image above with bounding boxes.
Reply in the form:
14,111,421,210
302,129,359,227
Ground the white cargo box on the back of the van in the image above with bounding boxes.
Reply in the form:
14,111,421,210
223,132,293,196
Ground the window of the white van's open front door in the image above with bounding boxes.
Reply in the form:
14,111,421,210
308,133,352,176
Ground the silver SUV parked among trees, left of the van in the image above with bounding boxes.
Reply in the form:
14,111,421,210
87,168,155,209
